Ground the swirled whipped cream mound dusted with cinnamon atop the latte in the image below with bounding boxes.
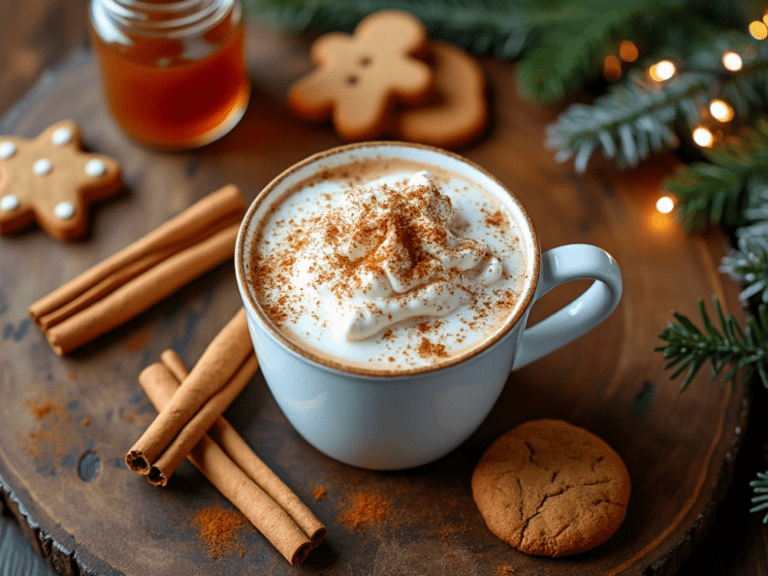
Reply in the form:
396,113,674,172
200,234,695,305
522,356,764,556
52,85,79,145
291,171,503,342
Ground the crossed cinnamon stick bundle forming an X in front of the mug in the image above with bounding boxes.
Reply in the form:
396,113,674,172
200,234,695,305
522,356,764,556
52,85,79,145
126,309,326,564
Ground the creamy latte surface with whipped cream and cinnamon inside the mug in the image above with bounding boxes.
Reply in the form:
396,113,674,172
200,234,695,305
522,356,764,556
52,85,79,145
245,153,531,375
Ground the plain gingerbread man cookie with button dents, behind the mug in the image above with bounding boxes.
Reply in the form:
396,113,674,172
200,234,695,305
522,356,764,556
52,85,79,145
288,10,432,141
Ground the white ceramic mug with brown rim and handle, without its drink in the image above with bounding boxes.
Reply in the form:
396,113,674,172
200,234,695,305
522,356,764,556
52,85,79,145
235,142,622,470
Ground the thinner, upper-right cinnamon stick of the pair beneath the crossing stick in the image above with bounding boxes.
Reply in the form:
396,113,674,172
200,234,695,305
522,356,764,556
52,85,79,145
162,350,326,547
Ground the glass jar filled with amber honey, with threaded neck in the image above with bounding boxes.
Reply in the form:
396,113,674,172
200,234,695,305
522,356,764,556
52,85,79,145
90,0,251,150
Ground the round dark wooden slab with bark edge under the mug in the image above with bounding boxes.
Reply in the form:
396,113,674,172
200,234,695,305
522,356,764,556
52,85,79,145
0,24,749,576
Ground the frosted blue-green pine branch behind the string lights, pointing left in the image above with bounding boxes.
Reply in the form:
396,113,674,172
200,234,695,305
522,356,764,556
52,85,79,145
546,32,768,172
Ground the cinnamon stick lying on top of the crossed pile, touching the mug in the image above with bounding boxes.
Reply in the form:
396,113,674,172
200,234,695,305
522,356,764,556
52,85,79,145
125,308,252,479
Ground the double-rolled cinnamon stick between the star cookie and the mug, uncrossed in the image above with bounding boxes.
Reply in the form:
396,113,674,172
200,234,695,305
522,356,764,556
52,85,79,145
29,185,245,356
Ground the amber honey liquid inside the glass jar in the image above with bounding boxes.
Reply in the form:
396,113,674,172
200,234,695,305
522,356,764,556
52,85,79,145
91,1,250,149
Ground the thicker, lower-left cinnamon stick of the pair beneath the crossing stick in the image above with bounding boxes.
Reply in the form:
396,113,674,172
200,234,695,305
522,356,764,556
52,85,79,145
139,362,312,564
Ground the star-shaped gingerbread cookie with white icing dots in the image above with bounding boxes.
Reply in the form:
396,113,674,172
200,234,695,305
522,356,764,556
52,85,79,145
0,120,122,240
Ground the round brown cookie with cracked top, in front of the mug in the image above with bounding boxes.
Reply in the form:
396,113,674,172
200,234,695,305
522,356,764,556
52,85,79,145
472,420,630,557
